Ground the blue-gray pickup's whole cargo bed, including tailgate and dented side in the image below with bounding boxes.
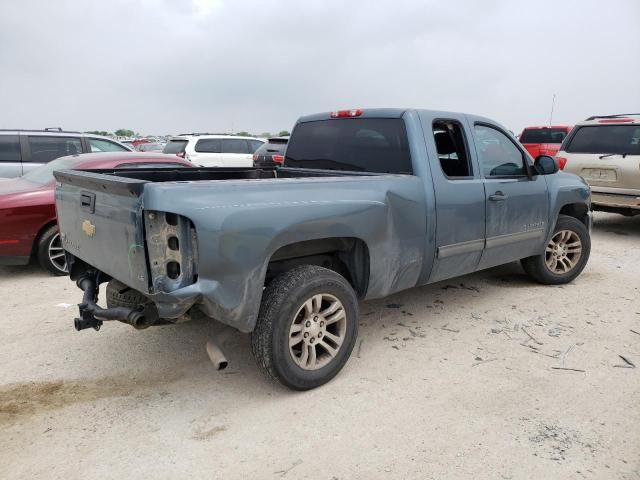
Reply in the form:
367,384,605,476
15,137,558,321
55,164,424,331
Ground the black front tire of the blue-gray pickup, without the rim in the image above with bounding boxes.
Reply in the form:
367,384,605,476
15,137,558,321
521,215,591,285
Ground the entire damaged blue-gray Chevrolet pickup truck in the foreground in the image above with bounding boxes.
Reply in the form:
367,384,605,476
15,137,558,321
55,109,591,390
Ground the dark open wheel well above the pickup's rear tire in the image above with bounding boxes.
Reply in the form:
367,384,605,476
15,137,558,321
265,237,369,297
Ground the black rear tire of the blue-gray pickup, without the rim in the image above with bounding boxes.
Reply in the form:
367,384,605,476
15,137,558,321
251,265,358,390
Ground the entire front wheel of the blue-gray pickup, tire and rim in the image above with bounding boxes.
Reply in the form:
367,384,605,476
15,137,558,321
522,215,591,285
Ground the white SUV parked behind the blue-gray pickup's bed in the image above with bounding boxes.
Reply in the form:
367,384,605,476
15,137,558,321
162,133,264,167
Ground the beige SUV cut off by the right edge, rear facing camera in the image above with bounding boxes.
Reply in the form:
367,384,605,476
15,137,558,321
556,113,640,215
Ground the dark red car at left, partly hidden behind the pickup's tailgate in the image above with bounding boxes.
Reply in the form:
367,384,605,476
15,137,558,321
0,152,193,275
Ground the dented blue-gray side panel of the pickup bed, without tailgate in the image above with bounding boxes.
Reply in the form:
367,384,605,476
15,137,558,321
136,175,426,331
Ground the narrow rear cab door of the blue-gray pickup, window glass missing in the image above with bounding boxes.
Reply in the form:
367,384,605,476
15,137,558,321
422,115,485,282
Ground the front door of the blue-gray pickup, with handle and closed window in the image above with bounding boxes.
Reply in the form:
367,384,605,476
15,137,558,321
473,122,549,268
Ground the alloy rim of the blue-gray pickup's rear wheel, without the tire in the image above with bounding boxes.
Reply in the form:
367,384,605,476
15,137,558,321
289,293,347,370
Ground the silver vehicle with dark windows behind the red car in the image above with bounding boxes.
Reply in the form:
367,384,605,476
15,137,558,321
0,128,132,178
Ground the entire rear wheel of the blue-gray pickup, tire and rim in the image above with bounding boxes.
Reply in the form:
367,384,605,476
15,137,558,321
251,265,358,390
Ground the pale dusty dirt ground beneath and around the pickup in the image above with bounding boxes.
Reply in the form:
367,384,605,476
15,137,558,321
0,214,640,480
